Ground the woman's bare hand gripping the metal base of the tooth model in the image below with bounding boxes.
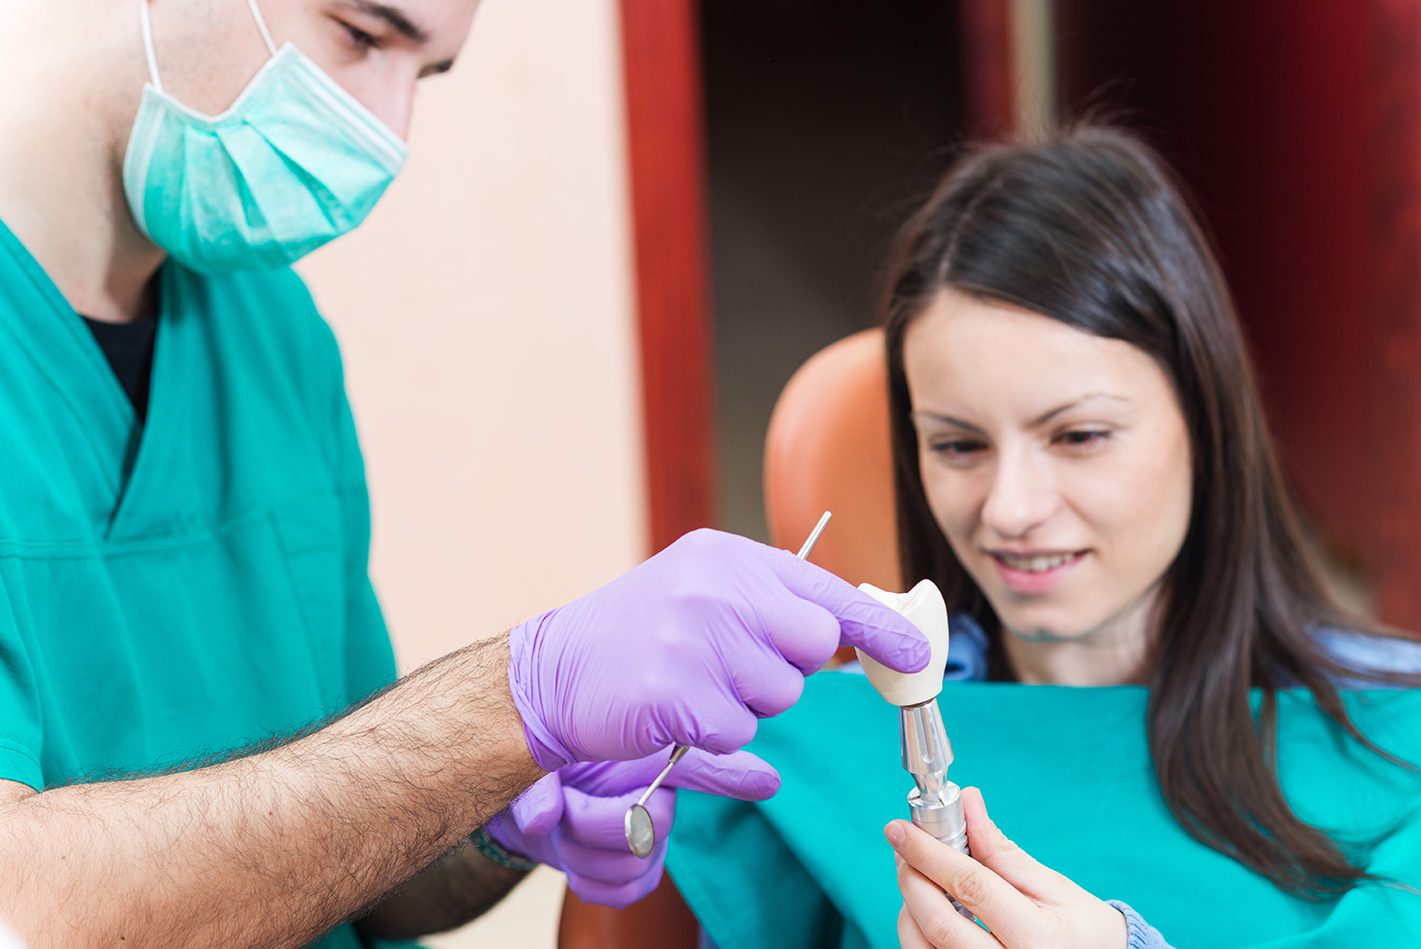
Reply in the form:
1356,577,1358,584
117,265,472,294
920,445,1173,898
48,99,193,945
884,787,1127,949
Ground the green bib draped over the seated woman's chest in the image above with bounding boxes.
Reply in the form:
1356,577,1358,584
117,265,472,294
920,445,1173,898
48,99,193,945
668,672,1421,949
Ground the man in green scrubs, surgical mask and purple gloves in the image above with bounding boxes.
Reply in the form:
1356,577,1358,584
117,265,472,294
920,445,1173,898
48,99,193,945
0,0,928,949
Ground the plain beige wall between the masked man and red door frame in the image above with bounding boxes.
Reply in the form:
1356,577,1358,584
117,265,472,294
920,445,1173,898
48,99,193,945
303,0,645,946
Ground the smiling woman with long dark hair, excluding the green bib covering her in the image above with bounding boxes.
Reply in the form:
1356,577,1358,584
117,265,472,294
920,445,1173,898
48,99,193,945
564,126,1421,949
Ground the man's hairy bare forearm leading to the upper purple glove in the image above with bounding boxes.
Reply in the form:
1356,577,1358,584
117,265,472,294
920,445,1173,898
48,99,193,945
0,636,541,949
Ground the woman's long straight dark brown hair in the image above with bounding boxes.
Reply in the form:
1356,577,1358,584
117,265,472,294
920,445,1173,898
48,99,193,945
881,125,1421,899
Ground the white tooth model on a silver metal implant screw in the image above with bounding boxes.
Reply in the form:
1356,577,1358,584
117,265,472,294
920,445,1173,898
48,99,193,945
858,580,973,919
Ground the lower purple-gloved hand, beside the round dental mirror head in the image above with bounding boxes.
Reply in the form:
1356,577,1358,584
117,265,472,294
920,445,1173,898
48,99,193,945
489,749,780,906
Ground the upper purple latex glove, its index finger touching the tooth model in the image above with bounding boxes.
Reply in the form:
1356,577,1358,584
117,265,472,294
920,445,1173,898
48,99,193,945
509,530,929,771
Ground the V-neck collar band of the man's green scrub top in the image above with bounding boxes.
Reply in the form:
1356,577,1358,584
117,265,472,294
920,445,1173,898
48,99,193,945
0,222,192,540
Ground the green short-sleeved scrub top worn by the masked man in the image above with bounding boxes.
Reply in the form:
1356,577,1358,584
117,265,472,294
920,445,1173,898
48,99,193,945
0,223,414,949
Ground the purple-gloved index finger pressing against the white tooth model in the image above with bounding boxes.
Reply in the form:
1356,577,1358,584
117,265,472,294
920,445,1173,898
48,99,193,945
764,547,932,672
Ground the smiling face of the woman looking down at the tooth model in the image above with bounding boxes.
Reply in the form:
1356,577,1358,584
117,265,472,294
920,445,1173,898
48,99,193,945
904,290,1191,641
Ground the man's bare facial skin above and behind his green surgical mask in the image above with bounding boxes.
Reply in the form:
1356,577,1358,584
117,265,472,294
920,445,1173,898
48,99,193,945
149,0,479,138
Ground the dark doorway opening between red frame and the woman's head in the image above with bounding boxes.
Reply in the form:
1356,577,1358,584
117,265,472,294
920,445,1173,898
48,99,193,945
701,0,963,538
